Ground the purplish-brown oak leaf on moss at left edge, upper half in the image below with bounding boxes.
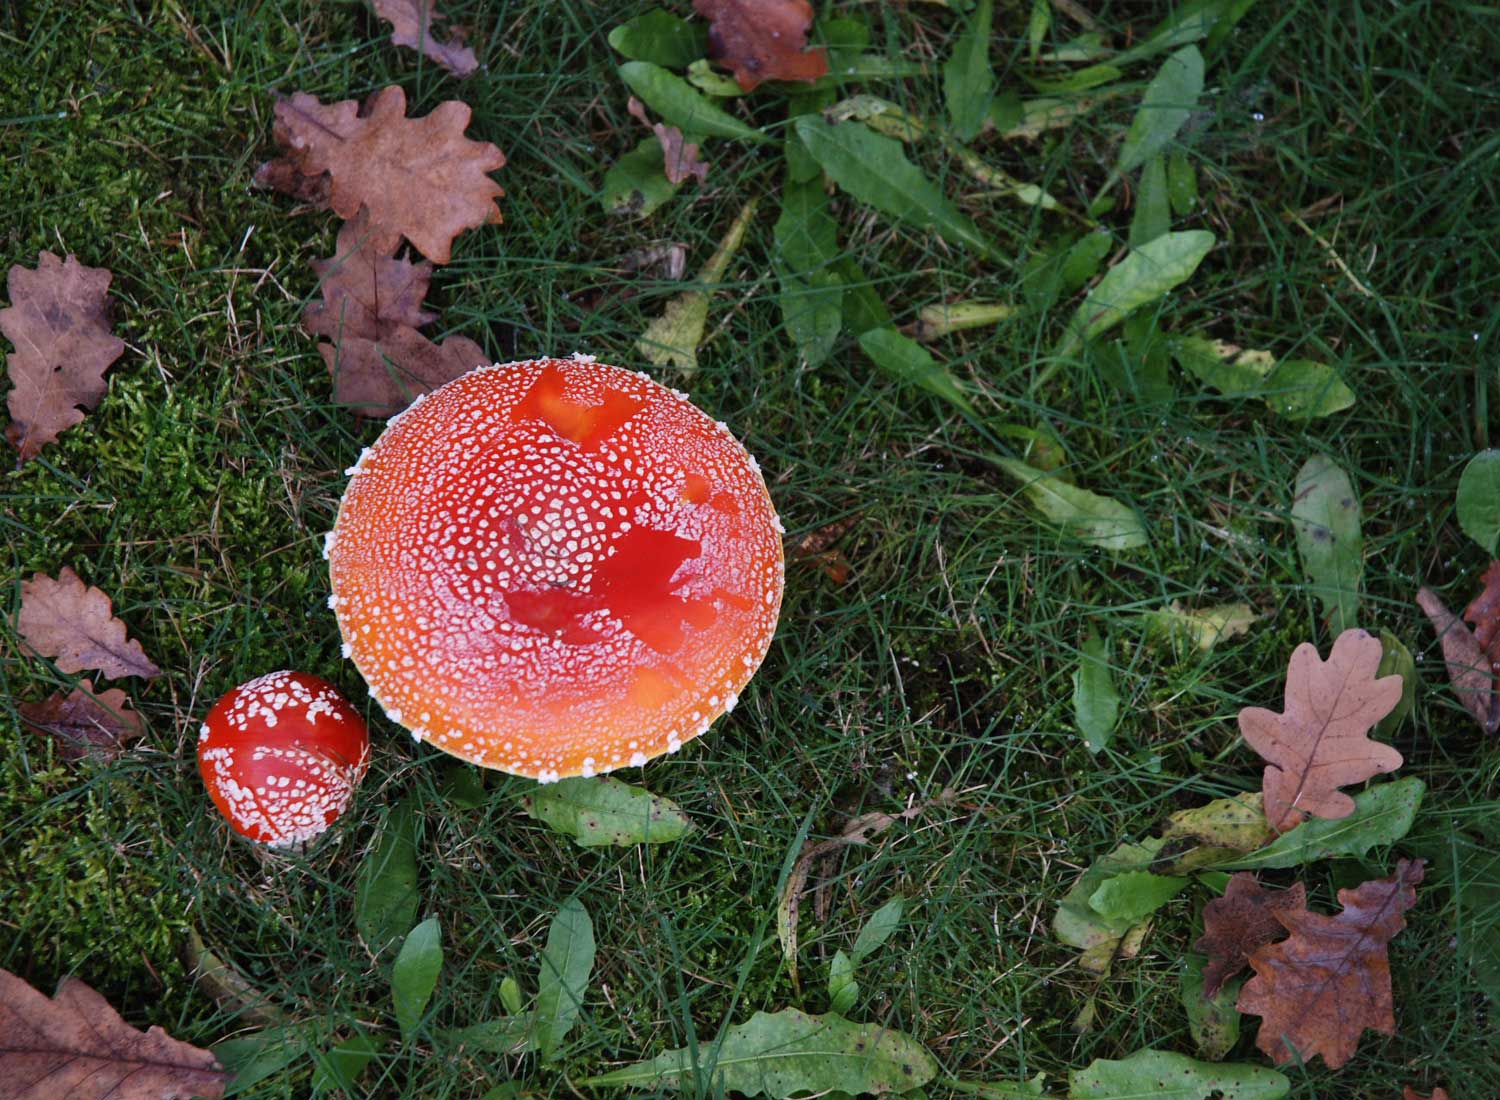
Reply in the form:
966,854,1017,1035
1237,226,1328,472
0,252,125,462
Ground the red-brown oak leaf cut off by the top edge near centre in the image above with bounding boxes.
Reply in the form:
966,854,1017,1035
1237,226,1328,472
693,0,828,92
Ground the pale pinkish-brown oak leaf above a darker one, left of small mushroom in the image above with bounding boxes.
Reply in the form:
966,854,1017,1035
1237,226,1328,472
17,566,162,680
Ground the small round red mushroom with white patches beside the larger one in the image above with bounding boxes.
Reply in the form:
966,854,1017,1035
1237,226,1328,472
198,671,371,848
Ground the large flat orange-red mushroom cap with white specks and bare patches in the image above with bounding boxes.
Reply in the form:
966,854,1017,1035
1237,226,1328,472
326,356,783,782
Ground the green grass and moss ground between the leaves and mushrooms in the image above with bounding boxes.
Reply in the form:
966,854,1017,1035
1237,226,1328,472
0,0,1500,1098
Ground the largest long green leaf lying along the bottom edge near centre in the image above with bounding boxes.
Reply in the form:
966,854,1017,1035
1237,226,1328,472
579,1008,938,1100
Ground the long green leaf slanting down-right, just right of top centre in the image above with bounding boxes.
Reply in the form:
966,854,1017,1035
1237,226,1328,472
792,114,1004,260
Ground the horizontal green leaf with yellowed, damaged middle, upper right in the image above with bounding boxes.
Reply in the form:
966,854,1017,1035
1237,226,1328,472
1172,336,1355,420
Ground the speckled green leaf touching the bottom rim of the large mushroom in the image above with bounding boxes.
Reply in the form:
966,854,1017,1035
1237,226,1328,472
521,776,693,848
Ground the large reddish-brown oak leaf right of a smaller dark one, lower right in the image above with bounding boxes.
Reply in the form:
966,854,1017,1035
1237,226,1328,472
1235,860,1422,1070
